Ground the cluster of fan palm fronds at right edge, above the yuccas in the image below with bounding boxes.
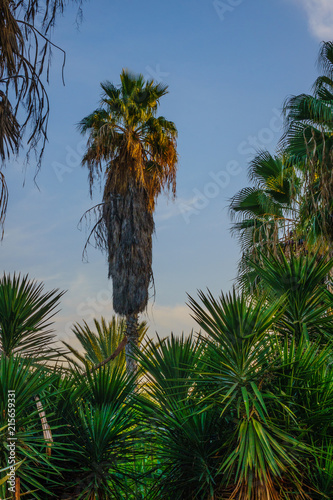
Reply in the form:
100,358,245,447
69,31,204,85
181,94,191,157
230,42,333,289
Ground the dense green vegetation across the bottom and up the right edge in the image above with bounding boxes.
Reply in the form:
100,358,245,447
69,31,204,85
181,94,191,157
0,35,333,500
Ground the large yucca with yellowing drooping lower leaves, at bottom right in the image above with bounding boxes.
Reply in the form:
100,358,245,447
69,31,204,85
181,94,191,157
185,291,318,500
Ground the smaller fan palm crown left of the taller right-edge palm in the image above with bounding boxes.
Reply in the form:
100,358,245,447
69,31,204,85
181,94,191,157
229,151,303,287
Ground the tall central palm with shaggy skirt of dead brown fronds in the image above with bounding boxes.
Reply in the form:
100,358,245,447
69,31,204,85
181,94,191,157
79,70,177,372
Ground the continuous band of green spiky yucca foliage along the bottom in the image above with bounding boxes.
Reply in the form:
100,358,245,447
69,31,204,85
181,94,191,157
0,260,333,500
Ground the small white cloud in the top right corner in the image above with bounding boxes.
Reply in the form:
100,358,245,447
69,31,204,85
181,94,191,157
296,0,333,41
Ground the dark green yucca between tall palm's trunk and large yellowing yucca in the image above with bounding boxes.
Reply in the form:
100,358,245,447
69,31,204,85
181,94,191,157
138,335,228,500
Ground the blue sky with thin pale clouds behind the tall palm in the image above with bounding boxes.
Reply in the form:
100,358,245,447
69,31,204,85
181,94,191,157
0,0,333,348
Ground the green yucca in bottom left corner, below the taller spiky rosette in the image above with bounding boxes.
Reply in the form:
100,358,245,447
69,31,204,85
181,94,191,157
0,355,63,500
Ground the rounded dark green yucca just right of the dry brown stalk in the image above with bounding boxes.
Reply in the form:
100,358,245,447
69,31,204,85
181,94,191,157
49,366,141,500
